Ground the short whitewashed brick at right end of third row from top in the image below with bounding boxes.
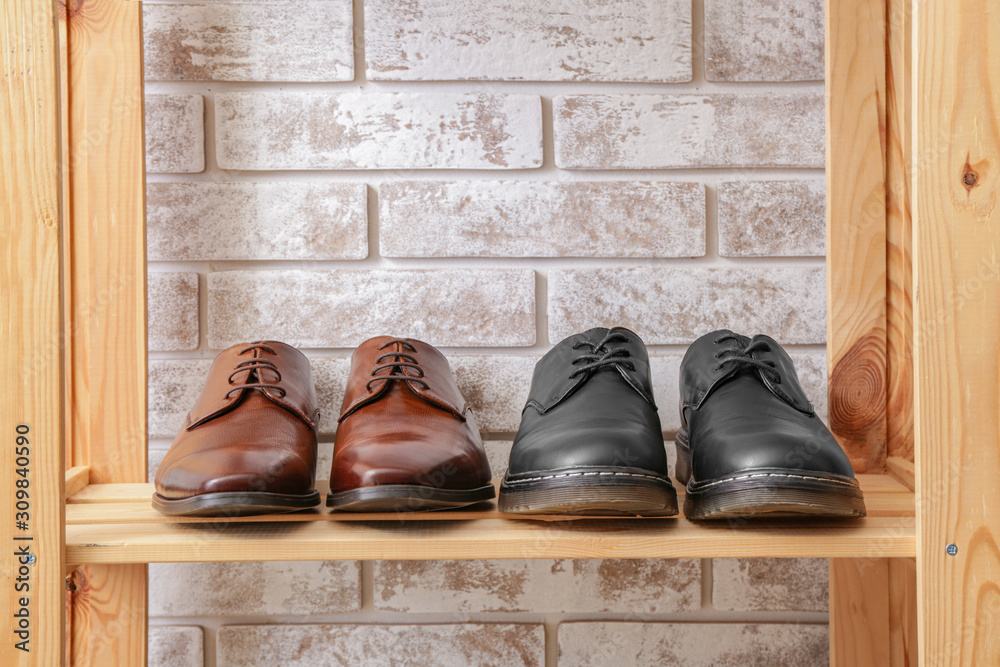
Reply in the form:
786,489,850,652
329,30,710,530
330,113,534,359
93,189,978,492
719,179,826,257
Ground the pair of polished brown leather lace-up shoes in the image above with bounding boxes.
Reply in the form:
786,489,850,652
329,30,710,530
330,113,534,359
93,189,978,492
153,336,495,516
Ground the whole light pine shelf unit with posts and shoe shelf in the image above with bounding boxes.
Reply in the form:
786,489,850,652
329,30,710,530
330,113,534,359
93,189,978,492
0,0,1000,667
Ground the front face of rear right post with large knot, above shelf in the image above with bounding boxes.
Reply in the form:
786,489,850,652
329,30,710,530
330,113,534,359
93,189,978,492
826,0,887,472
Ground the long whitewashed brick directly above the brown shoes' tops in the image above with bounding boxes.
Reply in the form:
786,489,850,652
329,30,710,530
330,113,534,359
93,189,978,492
208,269,535,349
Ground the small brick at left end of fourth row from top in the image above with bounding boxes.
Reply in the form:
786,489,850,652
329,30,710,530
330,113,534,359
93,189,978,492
146,272,198,352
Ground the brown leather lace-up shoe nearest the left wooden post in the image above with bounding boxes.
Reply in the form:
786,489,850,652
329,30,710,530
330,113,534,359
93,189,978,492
153,341,320,516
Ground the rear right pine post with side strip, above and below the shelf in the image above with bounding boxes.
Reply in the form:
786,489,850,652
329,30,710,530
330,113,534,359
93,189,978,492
826,0,916,667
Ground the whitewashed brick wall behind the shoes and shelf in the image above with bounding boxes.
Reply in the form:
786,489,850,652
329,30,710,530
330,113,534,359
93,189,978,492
144,0,828,667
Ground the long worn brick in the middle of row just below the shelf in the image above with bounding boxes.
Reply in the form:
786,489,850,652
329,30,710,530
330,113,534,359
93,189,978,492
374,559,701,613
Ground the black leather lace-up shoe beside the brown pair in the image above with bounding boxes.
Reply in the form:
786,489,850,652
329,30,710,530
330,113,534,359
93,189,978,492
499,327,677,516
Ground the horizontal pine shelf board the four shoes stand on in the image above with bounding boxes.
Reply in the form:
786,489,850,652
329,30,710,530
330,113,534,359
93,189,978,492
66,475,916,564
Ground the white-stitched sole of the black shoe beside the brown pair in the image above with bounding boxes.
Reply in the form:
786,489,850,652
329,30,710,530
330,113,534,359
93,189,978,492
498,468,678,517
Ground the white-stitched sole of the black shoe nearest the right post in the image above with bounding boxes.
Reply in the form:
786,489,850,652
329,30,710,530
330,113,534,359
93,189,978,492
684,470,866,521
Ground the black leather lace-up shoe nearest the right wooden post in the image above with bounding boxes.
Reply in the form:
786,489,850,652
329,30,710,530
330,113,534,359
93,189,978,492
676,330,865,519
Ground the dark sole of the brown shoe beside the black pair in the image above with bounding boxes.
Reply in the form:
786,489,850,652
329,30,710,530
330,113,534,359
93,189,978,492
326,484,496,512
